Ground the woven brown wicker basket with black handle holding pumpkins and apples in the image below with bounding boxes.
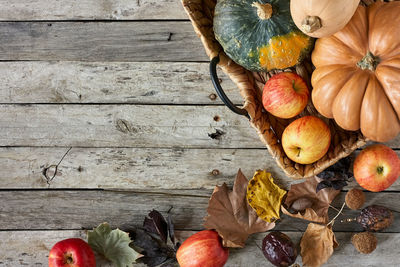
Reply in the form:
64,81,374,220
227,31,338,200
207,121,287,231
182,0,374,179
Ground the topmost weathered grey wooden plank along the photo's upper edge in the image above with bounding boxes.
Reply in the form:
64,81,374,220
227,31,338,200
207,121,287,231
0,0,187,21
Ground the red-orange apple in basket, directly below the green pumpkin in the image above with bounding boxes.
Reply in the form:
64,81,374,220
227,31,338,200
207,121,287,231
262,72,310,119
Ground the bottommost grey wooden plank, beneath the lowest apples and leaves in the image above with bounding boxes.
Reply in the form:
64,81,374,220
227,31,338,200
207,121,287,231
0,231,400,267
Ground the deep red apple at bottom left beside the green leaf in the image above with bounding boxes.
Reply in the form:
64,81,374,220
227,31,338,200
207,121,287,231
49,238,96,267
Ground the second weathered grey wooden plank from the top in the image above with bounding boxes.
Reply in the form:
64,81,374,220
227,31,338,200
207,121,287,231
0,21,209,62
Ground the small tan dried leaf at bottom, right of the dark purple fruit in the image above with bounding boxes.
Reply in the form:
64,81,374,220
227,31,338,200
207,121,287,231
300,223,339,267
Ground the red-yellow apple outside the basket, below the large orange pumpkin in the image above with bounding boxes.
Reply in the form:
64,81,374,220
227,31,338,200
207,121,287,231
353,144,400,192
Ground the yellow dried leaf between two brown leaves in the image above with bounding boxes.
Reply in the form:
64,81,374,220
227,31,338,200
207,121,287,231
247,170,286,222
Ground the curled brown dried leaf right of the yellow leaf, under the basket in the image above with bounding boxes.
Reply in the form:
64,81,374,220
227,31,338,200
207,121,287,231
282,176,340,223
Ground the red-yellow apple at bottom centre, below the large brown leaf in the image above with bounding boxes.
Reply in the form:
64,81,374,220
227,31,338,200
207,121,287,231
176,230,229,267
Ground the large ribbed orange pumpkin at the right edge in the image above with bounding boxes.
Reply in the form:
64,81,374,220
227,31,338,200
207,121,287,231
312,2,400,142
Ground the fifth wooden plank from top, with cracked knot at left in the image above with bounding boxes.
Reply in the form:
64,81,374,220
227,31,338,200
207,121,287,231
0,147,400,191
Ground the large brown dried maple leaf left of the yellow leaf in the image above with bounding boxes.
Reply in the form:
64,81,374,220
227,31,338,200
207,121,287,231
204,170,275,247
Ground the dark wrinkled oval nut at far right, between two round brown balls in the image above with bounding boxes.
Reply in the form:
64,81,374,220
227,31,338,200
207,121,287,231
357,205,394,232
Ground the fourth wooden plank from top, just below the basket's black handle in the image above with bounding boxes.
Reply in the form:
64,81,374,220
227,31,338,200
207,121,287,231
0,105,264,148
